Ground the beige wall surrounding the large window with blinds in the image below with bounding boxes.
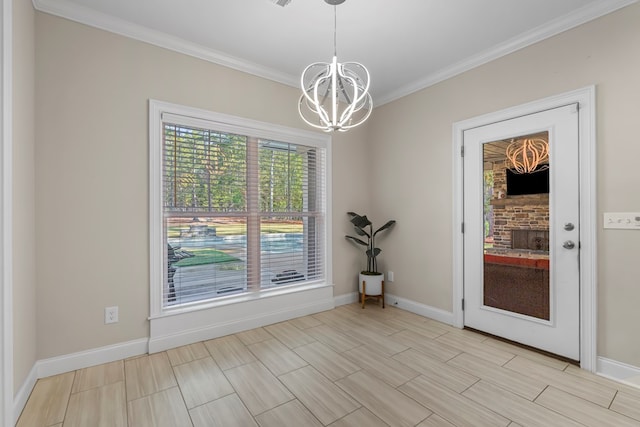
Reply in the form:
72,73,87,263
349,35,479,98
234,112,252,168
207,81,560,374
35,13,369,359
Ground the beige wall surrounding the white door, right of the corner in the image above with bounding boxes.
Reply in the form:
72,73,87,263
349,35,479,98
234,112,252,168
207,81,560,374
369,4,640,366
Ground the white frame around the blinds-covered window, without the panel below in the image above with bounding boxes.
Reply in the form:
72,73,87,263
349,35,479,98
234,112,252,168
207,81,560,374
149,99,332,319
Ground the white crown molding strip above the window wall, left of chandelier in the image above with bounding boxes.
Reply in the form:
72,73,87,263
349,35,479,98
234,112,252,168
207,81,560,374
33,0,299,87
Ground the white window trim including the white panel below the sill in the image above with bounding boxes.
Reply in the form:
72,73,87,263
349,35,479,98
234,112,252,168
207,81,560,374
149,99,333,352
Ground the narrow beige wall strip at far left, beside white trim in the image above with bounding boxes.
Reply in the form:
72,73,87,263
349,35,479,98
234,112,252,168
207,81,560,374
12,0,36,391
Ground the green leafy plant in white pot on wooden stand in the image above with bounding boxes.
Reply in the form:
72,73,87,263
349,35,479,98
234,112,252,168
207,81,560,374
345,212,396,300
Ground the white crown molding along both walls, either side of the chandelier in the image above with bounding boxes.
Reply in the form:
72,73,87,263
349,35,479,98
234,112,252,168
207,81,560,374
33,0,639,107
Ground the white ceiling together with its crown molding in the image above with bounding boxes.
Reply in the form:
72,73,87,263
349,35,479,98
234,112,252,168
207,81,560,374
33,0,637,105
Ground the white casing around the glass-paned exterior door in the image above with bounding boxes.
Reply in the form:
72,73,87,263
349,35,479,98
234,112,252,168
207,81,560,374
453,86,597,372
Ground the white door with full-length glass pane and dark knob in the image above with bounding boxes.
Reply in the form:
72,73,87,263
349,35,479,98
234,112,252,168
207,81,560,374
463,104,580,360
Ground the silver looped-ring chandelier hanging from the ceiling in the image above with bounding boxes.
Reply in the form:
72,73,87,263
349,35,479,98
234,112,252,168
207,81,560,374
298,0,373,132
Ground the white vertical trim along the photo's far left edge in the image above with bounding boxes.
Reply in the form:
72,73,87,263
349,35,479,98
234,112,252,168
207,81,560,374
0,0,15,426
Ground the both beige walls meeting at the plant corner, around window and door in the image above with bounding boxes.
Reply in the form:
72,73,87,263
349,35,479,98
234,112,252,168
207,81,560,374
35,1,640,366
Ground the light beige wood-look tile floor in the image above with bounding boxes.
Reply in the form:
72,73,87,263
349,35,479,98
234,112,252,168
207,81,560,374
18,304,640,427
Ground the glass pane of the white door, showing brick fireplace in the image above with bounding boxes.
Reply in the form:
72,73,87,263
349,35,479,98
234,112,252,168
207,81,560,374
483,132,550,320
